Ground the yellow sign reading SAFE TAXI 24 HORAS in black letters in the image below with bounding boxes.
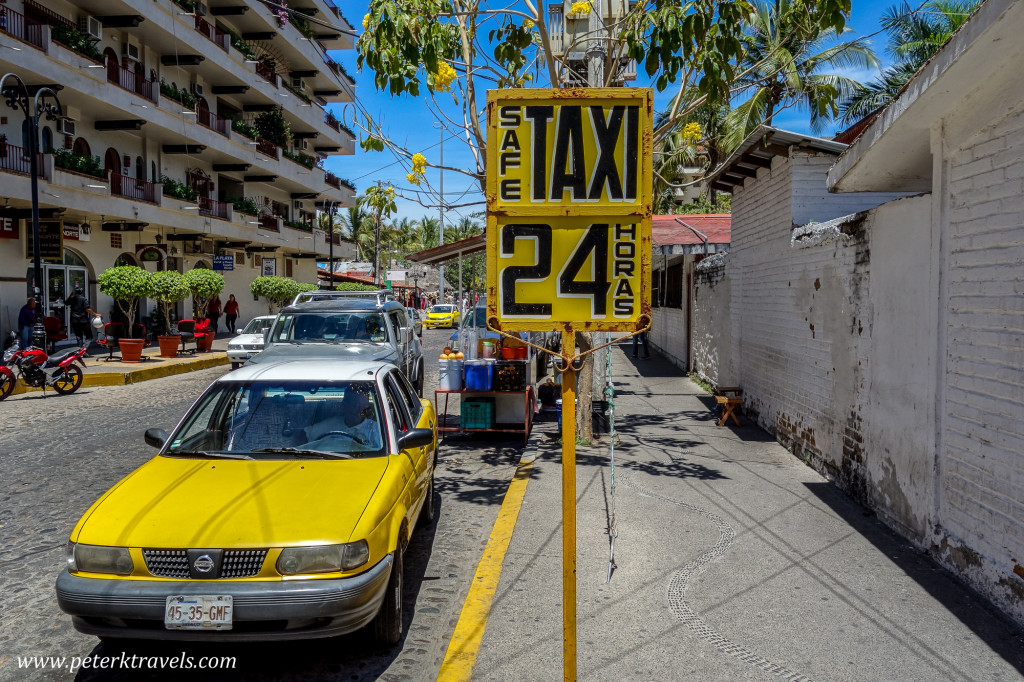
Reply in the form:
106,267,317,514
487,88,652,331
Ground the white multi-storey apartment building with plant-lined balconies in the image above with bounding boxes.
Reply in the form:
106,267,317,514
0,0,355,335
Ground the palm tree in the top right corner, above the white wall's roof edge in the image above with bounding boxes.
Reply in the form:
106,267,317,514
840,0,981,124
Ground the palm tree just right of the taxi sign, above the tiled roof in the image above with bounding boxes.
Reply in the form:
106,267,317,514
727,0,879,144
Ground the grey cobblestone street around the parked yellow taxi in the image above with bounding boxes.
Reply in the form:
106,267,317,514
0,331,521,680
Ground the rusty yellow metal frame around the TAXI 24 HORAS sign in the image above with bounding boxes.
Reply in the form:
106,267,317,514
486,88,653,334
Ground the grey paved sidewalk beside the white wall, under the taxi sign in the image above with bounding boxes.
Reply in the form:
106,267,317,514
473,346,1024,681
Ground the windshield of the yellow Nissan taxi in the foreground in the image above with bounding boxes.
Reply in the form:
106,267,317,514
165,381,385,459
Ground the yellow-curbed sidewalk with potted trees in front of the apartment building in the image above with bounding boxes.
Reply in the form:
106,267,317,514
14,333,233,394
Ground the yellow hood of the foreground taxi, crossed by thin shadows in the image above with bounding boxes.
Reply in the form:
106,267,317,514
72,450,389,548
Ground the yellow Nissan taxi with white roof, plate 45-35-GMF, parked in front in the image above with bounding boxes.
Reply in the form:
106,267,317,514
56,360,437,644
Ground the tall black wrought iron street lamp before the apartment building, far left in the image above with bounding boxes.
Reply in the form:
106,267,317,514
0,74,63,348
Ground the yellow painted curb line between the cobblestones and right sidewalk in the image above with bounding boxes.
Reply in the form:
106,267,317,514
437,448,534,682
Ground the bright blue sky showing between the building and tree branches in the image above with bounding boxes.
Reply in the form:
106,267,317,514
319,0,897,224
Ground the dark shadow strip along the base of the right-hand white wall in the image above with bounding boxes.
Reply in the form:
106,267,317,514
804,482,1024,679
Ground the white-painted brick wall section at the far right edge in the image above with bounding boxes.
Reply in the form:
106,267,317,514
935,102,1024,613
